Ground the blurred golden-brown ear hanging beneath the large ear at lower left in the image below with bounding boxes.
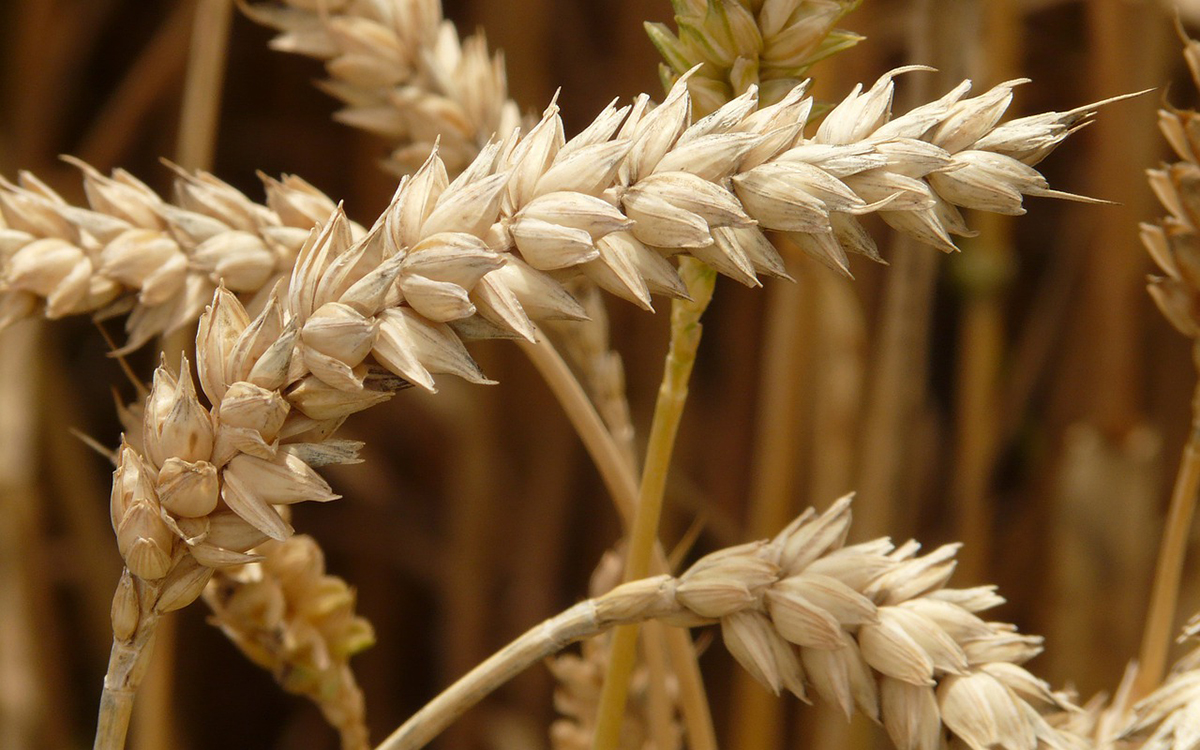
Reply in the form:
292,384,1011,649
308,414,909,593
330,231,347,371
204,535,374,750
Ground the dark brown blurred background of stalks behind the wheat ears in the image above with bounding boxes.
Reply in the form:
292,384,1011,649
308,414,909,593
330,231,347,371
0,0,1185,750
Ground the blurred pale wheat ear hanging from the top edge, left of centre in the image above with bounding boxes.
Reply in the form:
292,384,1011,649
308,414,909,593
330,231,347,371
242,0,521,174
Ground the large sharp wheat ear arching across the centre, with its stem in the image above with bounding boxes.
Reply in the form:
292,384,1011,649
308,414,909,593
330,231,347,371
65,67,1113,748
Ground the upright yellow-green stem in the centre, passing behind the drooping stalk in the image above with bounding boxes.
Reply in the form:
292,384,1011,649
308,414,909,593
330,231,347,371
593,258,716,750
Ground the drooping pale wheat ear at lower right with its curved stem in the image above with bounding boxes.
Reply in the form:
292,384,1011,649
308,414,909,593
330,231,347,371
379,497,1072,750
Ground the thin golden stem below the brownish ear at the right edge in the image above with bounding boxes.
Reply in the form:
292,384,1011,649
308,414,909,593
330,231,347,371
1134,376,1200,700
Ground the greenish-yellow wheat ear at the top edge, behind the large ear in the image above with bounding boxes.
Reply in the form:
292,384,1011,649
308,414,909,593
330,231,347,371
646,0,863,113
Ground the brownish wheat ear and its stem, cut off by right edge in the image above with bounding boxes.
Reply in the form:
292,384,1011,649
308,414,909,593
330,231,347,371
1134,27,1200,697
